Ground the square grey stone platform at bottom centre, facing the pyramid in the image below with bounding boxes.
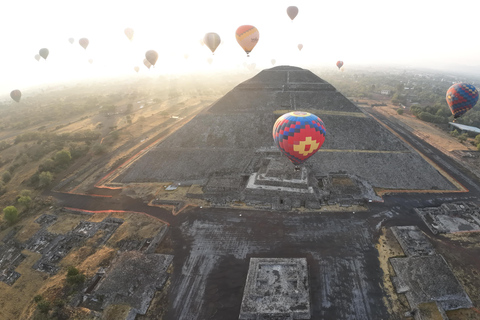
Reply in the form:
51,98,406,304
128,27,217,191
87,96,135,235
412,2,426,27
239,258,311,320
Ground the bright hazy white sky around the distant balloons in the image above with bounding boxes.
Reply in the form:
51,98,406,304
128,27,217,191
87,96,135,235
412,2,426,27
0,0,480,96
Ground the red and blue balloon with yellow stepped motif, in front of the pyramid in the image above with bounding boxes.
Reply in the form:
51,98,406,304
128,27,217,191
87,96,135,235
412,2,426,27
273,111,326,170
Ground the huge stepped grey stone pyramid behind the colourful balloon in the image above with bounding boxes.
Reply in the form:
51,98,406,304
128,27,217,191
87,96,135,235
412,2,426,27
115,66,455,206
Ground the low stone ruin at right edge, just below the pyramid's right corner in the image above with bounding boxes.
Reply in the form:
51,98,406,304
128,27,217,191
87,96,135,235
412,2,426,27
415,202,480,234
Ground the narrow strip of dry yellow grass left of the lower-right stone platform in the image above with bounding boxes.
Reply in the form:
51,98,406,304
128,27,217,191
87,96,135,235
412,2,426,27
375,228,410,316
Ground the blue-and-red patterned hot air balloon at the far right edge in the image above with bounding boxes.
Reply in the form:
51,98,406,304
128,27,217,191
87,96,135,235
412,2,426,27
446,83,478,119
